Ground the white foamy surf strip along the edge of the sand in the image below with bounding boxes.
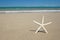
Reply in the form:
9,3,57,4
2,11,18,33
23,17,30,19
0,10,60,13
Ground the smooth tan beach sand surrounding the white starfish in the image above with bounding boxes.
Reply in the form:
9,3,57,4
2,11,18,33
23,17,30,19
0,12,60,40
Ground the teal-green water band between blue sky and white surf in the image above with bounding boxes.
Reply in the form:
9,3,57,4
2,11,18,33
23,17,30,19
0,7,60,11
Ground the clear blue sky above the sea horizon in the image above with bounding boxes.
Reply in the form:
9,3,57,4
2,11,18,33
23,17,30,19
0,0,60,7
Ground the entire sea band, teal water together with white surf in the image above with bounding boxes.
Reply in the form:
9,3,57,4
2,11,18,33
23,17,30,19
0,7,60,13
